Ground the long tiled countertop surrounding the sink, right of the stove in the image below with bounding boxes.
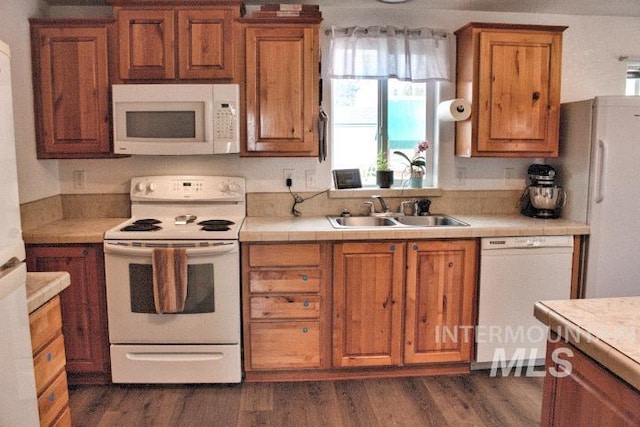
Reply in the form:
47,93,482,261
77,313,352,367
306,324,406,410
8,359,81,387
240,215,589,242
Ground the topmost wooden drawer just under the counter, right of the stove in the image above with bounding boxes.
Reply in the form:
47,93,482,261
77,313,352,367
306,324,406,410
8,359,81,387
249,244,320,267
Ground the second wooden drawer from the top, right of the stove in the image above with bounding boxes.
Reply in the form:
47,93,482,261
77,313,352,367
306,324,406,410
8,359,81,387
249,270,322,292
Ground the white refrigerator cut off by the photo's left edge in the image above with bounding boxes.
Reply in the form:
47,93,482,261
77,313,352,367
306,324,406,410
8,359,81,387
0,41,39,427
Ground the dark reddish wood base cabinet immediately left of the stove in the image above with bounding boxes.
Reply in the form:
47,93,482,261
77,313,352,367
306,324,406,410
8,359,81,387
27,246,110,383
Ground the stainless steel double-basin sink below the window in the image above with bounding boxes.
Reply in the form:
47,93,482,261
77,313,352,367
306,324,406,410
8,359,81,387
327,214,469,228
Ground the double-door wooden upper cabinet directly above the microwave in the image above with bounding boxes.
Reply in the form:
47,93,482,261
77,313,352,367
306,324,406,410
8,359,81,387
112,1,240,80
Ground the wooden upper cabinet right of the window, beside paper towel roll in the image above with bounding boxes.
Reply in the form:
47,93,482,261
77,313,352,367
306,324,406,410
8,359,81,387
455,23,567,157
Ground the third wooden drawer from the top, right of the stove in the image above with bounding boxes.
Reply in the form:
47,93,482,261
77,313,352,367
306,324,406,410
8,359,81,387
251,295,320,319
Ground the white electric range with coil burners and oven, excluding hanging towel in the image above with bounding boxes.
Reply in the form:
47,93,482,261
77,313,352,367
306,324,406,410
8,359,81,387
104,176,246,383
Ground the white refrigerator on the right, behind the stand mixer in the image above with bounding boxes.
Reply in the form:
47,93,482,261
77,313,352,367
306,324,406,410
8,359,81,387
549,96,640,298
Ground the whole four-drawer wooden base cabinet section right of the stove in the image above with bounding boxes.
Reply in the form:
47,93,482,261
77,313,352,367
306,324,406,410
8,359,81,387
242,243,330,380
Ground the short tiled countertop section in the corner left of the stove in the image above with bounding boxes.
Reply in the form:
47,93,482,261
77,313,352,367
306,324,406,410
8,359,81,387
22,218,128,244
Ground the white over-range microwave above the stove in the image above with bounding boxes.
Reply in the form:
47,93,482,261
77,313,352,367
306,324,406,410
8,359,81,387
112,84,240,155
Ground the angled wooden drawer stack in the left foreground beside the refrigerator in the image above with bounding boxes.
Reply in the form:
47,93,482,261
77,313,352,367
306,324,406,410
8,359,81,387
29,296,71,426
